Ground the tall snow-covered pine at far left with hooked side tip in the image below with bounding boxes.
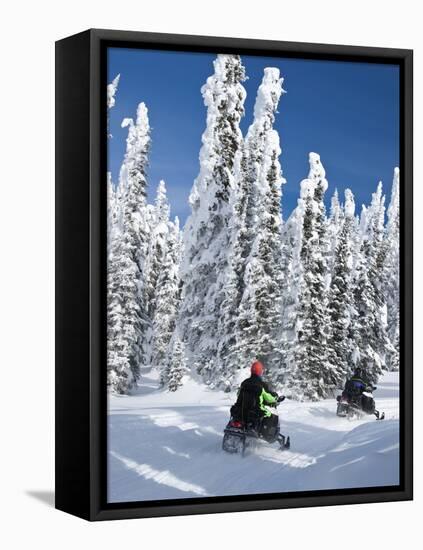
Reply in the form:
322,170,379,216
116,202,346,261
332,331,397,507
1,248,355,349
107,103,150,393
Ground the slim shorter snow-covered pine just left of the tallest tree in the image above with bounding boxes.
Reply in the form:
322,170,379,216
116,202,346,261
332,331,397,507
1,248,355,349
151,217,182,368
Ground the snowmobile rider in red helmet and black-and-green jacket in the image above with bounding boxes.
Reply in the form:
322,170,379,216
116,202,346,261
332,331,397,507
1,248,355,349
231,361,285,434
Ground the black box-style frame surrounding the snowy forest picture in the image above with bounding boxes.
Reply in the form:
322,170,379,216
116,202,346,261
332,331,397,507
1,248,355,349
55,29,413,521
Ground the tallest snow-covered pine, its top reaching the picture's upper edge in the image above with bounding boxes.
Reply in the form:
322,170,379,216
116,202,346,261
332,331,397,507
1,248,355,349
179,55,246,383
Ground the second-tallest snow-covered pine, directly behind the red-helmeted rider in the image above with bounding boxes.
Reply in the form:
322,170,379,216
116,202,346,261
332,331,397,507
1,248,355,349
219,68,285,384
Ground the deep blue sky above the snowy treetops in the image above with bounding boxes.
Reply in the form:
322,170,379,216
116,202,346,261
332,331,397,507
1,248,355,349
108,48,399,223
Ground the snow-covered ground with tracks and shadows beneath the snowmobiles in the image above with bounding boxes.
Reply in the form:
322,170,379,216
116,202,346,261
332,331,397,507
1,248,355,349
108,371,399,502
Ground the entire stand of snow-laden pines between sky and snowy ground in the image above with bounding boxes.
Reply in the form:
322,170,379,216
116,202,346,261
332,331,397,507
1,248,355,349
107,55,399,400
